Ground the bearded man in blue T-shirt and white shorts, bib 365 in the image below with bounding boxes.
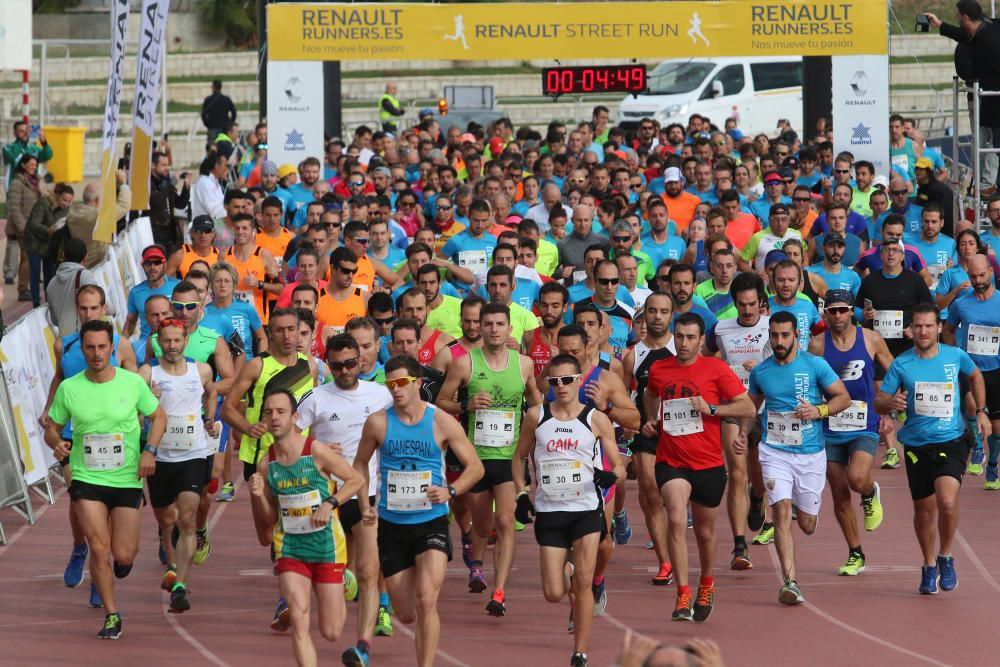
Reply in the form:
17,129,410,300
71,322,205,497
749,311,851,605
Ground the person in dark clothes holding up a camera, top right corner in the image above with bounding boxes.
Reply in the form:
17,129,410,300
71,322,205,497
917,0,1000,197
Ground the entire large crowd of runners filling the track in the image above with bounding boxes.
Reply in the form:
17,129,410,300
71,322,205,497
33,107,1000,667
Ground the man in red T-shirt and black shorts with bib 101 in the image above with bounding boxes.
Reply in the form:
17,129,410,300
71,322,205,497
642,313,755,622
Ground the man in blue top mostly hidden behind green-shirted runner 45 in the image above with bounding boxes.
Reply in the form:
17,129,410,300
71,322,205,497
40,285,137,607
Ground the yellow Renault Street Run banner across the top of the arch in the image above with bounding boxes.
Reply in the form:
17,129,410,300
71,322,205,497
267,0,888,61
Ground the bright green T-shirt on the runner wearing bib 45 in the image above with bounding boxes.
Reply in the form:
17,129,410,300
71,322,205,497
49,368,160,489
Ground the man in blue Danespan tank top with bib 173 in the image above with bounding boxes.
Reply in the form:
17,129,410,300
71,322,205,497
354,356,483,667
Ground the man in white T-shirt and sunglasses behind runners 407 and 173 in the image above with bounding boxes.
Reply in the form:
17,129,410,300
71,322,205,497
296,334,392,665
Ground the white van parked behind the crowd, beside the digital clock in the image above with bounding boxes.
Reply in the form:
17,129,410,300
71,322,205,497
618,56,802,135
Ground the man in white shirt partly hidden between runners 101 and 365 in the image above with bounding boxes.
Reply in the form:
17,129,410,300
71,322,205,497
705,273,774,570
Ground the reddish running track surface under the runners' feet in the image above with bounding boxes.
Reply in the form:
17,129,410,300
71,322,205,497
0,469,1000,667
